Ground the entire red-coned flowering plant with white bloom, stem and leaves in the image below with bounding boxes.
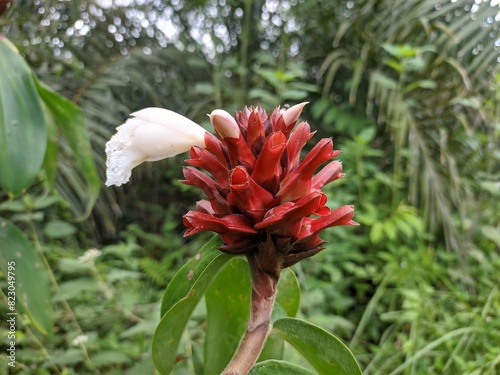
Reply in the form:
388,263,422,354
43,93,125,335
106,103,361,374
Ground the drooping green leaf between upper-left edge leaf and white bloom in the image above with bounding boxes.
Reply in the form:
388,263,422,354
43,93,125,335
35,80,101,220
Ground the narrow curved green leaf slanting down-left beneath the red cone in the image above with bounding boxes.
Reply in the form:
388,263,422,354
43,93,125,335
152,236,232,374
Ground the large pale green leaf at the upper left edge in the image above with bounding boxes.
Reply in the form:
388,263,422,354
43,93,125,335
0,35,47,194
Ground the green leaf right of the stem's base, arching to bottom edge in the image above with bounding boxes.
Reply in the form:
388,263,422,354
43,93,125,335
273,318,361,375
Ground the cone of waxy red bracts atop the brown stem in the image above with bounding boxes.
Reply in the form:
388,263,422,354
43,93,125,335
183,103,357,267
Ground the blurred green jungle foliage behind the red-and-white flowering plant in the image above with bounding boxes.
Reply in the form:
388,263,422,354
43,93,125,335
0,0,500,374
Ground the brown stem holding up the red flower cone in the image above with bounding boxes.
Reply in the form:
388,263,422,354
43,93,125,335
222,240,283,375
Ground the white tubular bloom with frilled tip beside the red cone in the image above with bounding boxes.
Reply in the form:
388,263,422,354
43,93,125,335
106,108,206,186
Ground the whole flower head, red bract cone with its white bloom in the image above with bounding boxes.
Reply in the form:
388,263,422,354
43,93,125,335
106,103,357,267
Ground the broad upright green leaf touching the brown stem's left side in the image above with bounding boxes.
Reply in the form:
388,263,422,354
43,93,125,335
204,258,252,374
